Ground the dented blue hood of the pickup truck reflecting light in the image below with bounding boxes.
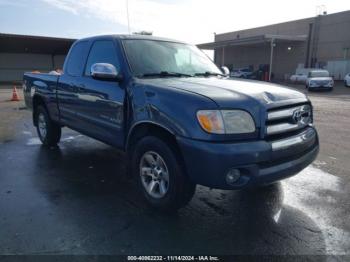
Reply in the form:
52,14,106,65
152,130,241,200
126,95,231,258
141,77,308,108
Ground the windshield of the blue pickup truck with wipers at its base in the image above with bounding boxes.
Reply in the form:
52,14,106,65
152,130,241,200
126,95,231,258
123,39,222,77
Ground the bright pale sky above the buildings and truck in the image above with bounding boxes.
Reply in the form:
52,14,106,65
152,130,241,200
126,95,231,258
0,0,350,44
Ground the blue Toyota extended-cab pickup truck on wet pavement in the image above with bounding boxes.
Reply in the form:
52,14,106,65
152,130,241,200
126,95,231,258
23,35,319,210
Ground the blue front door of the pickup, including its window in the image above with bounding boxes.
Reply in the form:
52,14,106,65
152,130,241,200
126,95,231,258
76,40,125,147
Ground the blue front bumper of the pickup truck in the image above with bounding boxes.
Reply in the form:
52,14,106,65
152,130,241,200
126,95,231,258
177,127,319,189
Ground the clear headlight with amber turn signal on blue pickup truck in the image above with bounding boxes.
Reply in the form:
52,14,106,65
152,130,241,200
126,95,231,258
197,110,255,134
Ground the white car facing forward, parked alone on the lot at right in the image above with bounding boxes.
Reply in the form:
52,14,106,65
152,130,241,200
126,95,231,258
306,70,334,91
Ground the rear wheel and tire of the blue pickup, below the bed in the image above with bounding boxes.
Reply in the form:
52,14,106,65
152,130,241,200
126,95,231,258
35,106,61,146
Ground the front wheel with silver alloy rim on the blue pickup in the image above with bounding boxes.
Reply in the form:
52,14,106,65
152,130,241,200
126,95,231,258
131,136,196,211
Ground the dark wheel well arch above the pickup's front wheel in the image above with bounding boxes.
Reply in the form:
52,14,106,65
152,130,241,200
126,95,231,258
126,123,182,158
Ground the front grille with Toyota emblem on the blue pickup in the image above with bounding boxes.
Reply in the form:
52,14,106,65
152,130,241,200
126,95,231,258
265,104,312,139
